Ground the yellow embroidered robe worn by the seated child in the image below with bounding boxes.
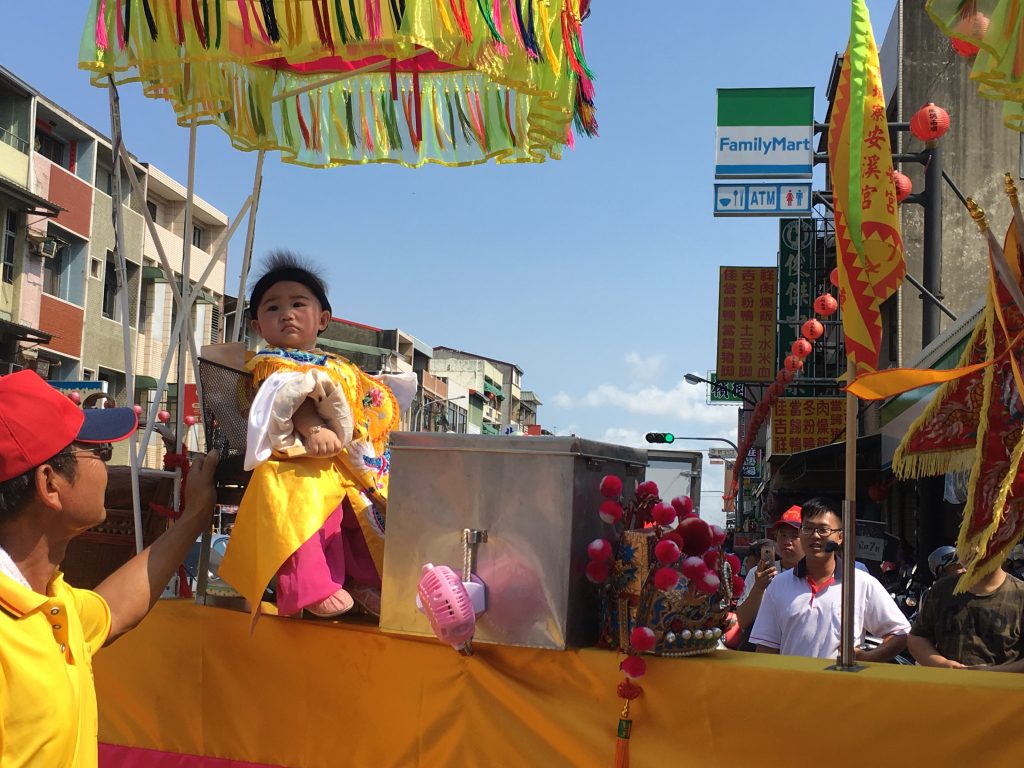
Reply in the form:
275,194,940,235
219,348,399,612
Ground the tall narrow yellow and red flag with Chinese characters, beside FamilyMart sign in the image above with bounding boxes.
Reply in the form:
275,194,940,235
828,0,906,381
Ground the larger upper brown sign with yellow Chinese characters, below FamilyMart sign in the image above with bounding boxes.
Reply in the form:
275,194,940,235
716,266,778,382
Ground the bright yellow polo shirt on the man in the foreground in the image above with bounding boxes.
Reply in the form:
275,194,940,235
0,571,111,768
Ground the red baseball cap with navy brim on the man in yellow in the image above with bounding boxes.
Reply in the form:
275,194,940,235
0,371,138,482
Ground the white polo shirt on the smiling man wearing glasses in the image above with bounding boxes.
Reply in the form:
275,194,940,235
751,561,910,658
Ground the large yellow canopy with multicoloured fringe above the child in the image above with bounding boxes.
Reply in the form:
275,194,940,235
79,0,597,167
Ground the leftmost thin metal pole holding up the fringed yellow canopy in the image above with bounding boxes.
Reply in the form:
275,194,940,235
103,77,145,554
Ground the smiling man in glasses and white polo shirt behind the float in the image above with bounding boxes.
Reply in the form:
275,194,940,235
751,498,910,662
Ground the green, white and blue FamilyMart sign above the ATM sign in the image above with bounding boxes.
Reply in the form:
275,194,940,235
715,88,814,178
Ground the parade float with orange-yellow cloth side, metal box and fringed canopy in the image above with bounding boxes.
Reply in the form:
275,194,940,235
72,0,1024,768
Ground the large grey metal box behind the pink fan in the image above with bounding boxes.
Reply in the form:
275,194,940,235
380,432,647,649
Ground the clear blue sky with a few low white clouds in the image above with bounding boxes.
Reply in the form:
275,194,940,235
0,0,896,521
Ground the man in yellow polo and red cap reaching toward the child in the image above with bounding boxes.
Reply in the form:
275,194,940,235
0,371,217,768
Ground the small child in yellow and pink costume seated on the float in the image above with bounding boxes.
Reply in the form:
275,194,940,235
219,253,416,616
